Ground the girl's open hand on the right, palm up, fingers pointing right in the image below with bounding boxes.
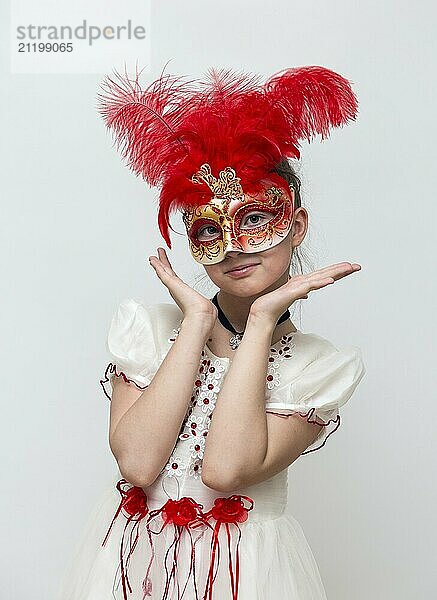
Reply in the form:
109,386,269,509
250,262,361,324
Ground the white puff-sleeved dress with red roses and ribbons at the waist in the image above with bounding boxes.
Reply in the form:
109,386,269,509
60,298,365,600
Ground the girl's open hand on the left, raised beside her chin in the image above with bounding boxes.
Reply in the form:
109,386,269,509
149,248,217,332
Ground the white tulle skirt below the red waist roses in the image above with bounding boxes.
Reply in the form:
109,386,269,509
58,474,326,600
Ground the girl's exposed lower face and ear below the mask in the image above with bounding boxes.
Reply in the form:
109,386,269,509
203,207,308,297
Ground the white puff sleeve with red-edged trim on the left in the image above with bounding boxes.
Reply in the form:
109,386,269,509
100,298,158,399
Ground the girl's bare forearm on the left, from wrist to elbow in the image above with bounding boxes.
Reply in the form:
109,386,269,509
111,319,209,485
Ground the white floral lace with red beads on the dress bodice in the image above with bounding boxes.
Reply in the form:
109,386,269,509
161,322,295,479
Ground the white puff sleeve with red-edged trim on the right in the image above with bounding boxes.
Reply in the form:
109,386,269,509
266,346,366,454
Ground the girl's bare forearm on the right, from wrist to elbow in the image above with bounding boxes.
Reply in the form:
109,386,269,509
202,315,274,490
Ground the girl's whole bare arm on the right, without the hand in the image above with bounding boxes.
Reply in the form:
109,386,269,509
202,315,321,492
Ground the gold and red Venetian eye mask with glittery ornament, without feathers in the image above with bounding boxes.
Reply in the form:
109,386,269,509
182,163,294,265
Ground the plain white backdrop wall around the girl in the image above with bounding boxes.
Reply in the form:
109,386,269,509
0,0,437,600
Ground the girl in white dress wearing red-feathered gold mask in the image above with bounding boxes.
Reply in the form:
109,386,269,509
58,67,365,600
